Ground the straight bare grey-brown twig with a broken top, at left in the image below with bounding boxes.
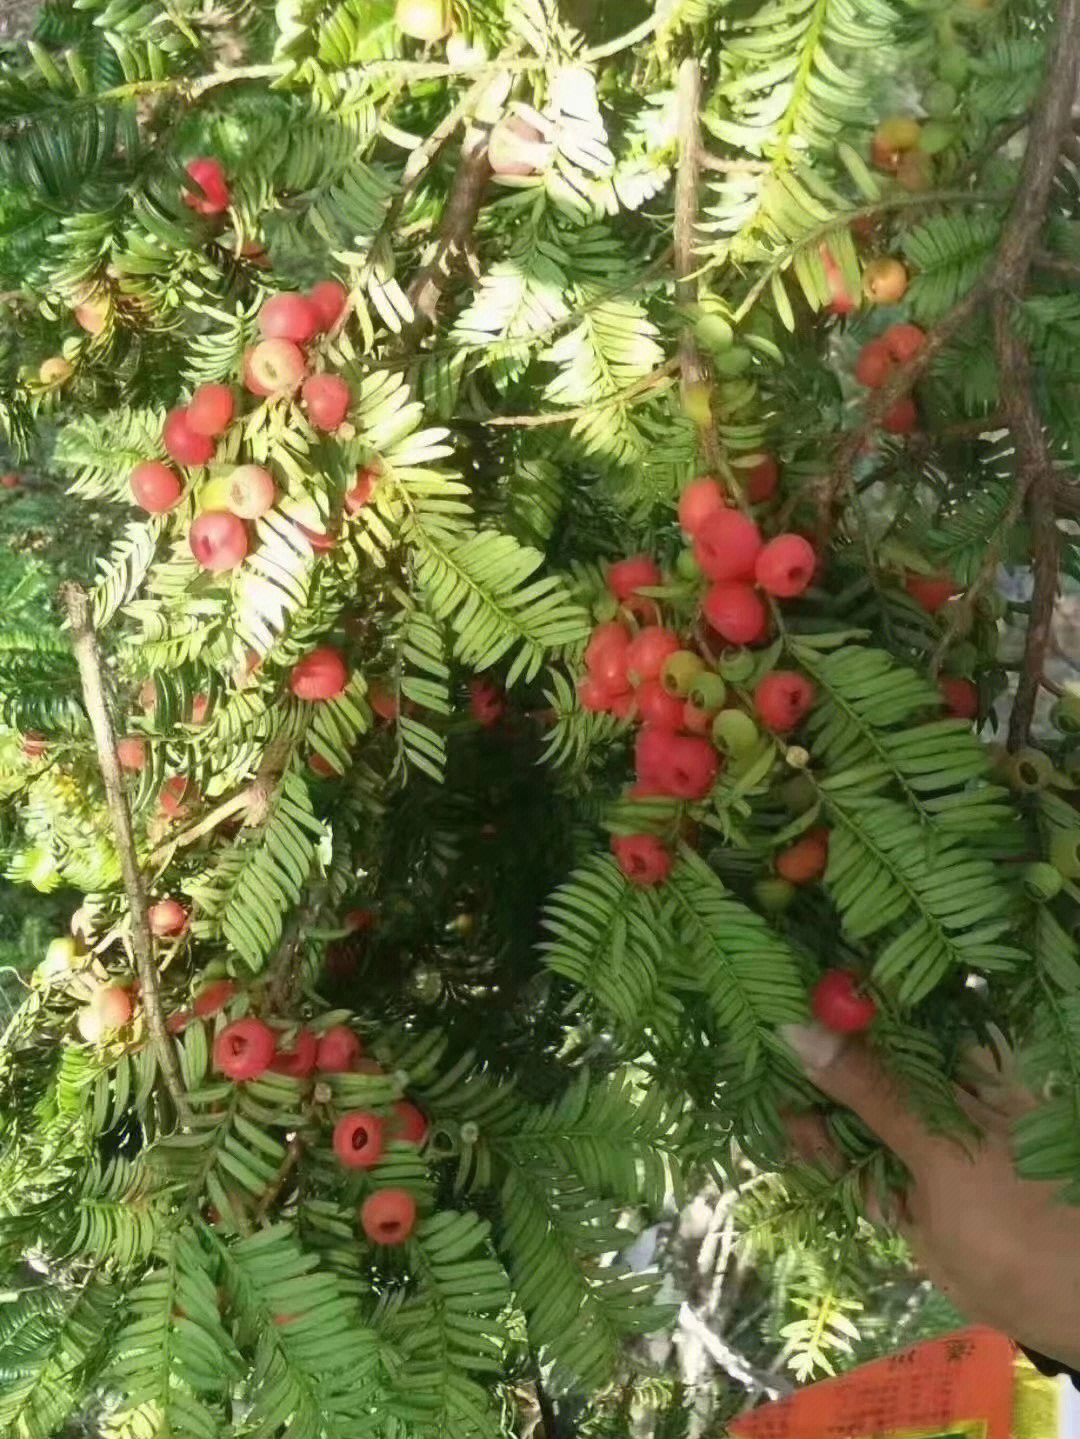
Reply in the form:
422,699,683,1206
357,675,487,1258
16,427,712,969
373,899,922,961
62,584,191,1127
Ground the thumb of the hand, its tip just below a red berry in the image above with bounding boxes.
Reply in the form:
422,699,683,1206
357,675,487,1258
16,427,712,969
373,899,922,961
779,1025,935,1171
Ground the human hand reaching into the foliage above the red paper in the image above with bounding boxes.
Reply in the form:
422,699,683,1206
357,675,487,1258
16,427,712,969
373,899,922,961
781,1025,1080,1368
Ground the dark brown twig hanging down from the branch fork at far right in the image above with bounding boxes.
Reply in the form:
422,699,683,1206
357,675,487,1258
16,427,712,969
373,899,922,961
994,296,1061,750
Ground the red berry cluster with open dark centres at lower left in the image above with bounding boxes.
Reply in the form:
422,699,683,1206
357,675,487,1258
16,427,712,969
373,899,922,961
208,1013,429,1245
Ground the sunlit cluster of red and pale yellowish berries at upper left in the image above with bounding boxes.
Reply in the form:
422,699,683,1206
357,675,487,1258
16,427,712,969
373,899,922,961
131,279,350,574
